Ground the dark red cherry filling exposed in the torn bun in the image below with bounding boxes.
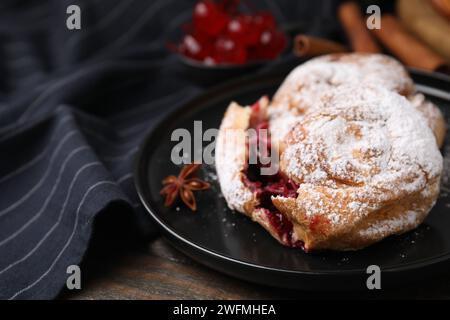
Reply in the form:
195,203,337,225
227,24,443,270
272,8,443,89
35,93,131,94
243,102,304,248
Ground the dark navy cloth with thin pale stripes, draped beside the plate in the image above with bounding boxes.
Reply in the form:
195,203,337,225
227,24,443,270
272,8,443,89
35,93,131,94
0,0,338,299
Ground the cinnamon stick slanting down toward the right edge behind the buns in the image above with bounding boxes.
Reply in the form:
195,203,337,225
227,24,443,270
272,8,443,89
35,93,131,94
372,15,446,71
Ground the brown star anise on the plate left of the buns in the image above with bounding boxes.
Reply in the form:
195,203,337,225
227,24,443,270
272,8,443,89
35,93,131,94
160,164,210,211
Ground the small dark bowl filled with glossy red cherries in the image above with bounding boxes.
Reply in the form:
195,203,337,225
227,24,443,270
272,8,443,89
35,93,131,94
170,0,288,83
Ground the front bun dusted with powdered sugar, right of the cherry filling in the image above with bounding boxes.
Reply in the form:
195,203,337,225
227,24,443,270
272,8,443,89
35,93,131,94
273,86,443,250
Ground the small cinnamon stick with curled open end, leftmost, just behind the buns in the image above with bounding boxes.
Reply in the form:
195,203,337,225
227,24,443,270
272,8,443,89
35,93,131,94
294,34,349,58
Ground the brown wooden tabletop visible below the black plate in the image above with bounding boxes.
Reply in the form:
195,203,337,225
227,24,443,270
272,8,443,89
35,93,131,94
62,231,450,299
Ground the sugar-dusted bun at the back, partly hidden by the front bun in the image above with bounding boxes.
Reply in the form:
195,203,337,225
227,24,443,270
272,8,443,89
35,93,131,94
269,53,446,146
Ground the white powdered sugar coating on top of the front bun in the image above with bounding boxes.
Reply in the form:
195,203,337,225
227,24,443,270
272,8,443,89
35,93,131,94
281,85,443,229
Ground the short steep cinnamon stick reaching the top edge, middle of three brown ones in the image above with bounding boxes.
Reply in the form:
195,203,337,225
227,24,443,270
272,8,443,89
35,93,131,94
338,2,381,53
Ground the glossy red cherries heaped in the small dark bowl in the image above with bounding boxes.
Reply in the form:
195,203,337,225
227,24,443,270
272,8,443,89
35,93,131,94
175,0,286,64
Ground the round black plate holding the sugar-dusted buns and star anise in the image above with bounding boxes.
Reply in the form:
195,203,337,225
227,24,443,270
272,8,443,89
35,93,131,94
135,70,450,290
